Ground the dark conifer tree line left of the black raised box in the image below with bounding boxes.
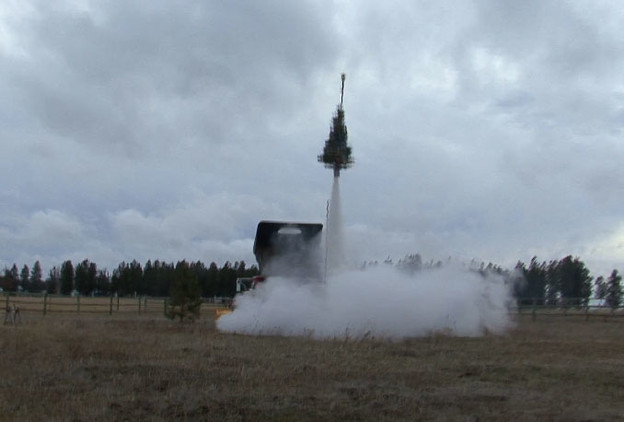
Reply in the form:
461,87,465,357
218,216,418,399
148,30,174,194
0,259,259,297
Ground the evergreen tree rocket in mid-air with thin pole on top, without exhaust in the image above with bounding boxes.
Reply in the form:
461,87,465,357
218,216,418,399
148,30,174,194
318,73,353,177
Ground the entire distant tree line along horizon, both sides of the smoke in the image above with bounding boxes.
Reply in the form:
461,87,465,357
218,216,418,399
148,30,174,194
0,254,624,308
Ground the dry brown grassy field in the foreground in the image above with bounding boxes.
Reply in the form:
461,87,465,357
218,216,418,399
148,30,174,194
0,312,624,422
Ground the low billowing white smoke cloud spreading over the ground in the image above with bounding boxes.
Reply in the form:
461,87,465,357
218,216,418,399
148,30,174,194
217,266,512,339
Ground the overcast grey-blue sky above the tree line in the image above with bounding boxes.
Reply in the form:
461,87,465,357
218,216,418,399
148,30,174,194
0,0,624,275
